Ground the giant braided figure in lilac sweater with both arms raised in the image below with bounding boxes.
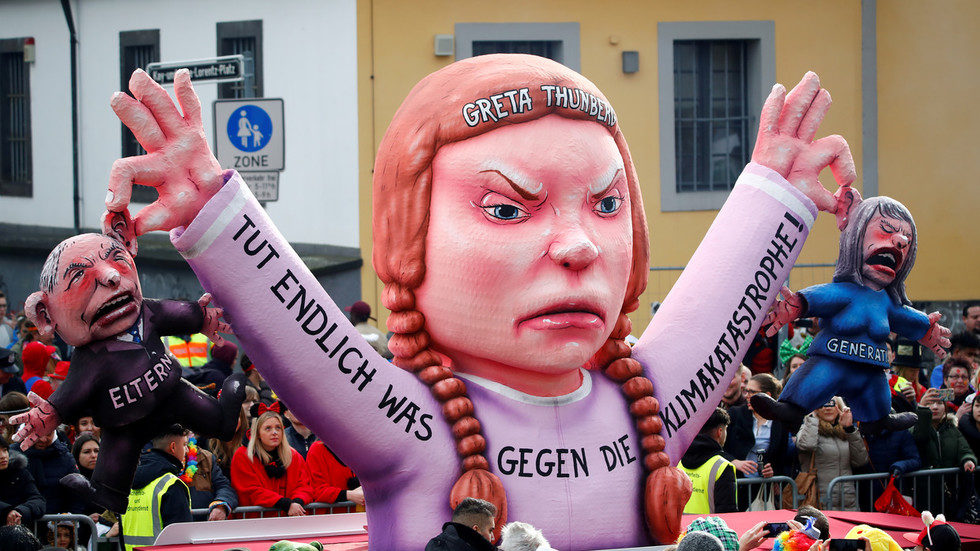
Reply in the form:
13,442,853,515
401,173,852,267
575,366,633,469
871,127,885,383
17,55,854,550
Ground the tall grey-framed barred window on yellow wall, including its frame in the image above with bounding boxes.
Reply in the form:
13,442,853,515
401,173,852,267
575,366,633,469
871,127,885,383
658,21,775,211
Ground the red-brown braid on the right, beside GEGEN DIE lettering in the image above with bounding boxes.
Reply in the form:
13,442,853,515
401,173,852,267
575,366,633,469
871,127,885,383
593,312,692,543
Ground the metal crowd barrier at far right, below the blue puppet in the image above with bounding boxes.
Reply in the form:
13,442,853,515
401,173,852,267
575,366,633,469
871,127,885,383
820,467,964,516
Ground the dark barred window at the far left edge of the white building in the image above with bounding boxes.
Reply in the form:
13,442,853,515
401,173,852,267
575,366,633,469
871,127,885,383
0,38,33,197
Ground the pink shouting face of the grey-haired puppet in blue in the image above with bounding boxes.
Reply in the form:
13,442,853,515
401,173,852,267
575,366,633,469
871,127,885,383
861,213,912,291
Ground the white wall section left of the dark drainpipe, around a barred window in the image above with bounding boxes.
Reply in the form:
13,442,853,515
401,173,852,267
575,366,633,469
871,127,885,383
0,0,73,227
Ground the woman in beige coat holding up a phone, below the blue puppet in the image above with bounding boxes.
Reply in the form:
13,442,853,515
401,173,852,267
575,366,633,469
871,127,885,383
796,396,868,511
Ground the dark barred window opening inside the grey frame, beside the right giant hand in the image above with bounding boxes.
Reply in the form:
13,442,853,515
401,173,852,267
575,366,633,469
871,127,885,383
674,40,752,193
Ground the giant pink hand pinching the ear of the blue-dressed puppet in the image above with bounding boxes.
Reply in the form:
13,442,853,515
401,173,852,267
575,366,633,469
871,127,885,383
752,72,857,218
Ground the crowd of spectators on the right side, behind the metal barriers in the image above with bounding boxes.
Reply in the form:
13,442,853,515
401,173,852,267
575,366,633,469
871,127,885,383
681,303,980,520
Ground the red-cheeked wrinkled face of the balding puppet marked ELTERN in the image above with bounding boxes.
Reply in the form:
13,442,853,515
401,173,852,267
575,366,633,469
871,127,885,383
45,234,143,346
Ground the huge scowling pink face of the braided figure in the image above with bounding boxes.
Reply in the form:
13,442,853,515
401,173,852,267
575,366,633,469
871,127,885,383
416,115,633,386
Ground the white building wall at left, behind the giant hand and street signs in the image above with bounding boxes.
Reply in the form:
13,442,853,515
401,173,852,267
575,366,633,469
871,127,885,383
0,0,358,247
